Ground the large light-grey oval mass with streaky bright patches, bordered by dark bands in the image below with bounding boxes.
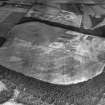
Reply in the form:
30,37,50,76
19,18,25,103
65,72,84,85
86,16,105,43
0,22,105,85
